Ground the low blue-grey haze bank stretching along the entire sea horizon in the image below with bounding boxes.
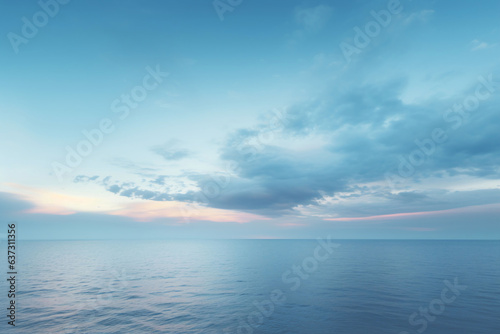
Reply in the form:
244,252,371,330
0,189,499,240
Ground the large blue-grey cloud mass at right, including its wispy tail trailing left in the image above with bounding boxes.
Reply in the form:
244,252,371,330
76,72,500,217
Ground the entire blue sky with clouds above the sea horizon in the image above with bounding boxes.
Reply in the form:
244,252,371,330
0,0,500,240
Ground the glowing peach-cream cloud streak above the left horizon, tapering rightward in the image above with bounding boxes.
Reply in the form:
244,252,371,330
0,183,268,223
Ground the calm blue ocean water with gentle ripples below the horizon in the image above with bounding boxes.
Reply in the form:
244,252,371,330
0,240,500,334
